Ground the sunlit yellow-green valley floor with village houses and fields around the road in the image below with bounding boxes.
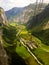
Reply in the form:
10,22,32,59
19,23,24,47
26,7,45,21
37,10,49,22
3,23,49,65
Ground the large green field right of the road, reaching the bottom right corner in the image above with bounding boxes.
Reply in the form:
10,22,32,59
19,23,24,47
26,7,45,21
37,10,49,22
33,36,49,65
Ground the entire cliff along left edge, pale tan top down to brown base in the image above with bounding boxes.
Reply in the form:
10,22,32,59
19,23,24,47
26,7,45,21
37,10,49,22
0,7,8,65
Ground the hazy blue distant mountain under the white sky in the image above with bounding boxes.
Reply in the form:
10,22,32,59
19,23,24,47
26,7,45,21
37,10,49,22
5,7,24,19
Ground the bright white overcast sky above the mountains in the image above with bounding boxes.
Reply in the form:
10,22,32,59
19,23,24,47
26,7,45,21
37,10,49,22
0,0,49,10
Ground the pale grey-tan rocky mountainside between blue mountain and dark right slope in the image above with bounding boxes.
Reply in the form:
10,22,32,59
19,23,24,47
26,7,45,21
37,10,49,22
15,4,35,24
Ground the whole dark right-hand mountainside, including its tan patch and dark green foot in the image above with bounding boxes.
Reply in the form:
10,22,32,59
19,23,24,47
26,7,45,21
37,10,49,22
27,4,49,45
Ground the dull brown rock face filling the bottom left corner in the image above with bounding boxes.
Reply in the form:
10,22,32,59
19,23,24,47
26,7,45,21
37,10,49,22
0,43,8,65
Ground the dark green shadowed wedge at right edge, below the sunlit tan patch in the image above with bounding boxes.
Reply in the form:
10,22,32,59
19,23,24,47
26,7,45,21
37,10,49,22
32,29,49,45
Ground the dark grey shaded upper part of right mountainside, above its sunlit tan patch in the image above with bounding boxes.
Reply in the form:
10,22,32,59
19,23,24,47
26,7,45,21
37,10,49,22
27,4,49,29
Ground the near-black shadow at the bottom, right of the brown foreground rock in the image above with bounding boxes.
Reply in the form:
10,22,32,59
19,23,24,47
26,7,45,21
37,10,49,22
6,47,26,65
